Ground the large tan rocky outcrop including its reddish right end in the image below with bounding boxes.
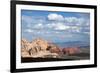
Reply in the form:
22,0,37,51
21,38,60,58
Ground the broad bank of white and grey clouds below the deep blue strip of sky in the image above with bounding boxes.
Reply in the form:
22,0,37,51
21,12,90,40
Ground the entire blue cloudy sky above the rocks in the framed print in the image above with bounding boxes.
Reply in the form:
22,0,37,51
21,10,90,42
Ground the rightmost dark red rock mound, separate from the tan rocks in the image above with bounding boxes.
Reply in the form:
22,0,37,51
62,47,80,55
